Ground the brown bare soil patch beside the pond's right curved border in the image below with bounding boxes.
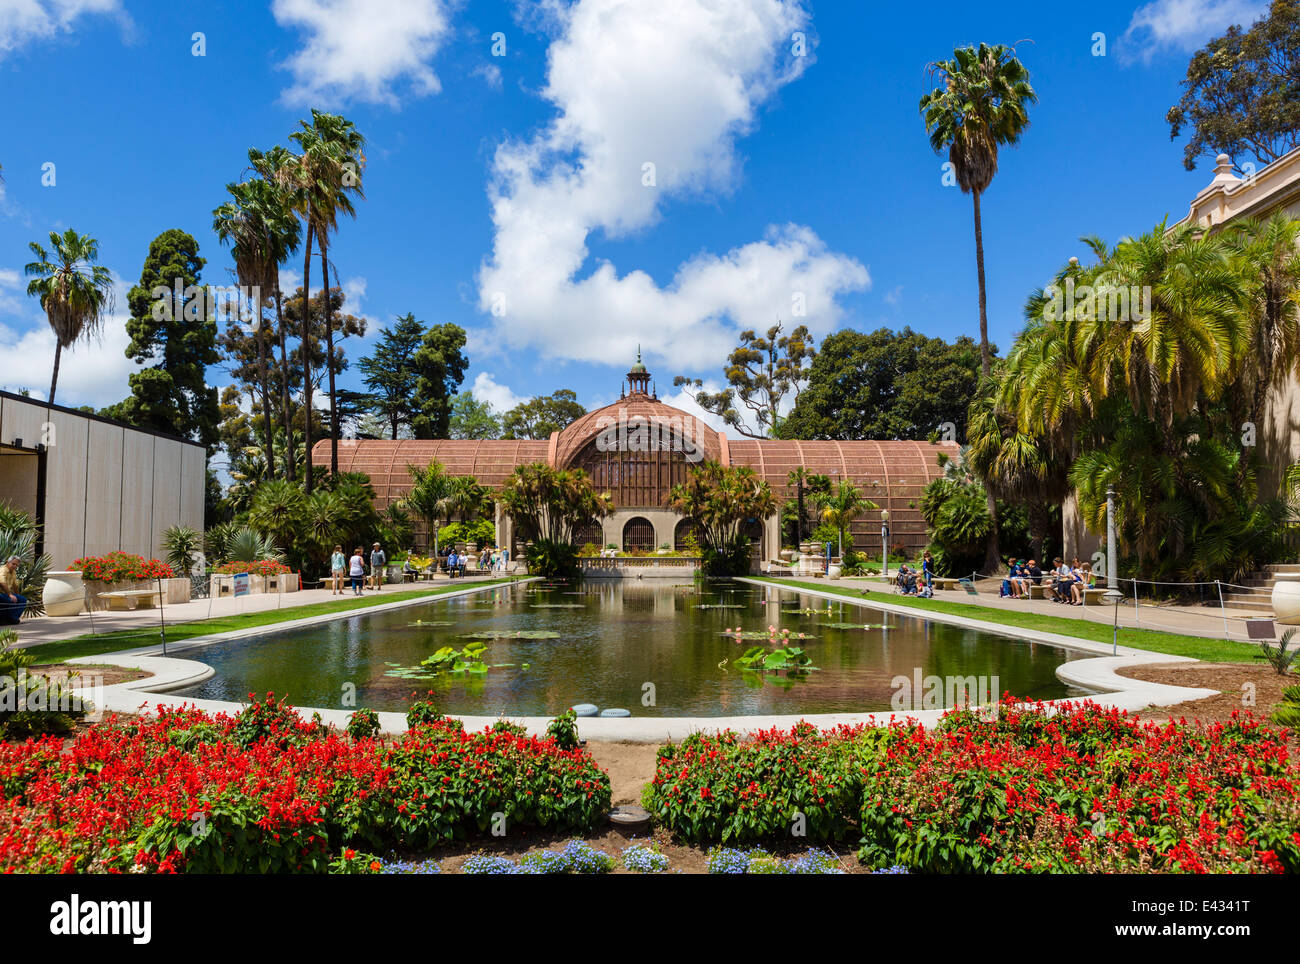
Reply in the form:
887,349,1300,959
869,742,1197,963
1117,660,1300,744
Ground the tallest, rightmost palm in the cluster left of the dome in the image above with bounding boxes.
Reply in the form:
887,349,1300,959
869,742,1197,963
289,109,365,491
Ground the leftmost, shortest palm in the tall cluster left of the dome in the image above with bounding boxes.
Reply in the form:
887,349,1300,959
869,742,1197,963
212,179,298,478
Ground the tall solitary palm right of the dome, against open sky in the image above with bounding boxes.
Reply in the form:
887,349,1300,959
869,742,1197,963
920,44,1037,377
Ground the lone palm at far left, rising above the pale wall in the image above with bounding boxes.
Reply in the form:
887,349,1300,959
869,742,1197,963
23,227,113,405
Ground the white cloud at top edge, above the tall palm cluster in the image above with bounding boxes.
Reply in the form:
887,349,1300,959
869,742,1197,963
270,0,451,107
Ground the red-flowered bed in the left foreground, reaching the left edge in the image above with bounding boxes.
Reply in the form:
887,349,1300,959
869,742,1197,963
0,696,610,873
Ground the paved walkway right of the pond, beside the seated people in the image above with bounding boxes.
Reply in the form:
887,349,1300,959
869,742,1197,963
772,577,1281,641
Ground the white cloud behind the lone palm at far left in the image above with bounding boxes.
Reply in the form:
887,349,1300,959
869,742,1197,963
0,269,140,408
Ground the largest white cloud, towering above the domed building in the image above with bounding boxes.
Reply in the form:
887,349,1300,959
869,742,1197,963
478,0,870,373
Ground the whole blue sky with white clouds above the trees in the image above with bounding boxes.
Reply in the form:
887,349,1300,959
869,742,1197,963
0,0,1265,433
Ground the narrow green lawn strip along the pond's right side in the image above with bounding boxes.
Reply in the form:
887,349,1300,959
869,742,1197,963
755,577,1260,663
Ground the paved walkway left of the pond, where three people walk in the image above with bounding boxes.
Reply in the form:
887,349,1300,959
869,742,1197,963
8,573,501,648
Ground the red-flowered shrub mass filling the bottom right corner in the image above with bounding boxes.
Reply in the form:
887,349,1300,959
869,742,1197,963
858,703,1300,873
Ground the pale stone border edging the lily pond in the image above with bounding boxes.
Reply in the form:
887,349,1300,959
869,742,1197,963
68,577,1218,743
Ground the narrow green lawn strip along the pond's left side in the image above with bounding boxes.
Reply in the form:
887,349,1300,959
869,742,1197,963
27,576,527,663
